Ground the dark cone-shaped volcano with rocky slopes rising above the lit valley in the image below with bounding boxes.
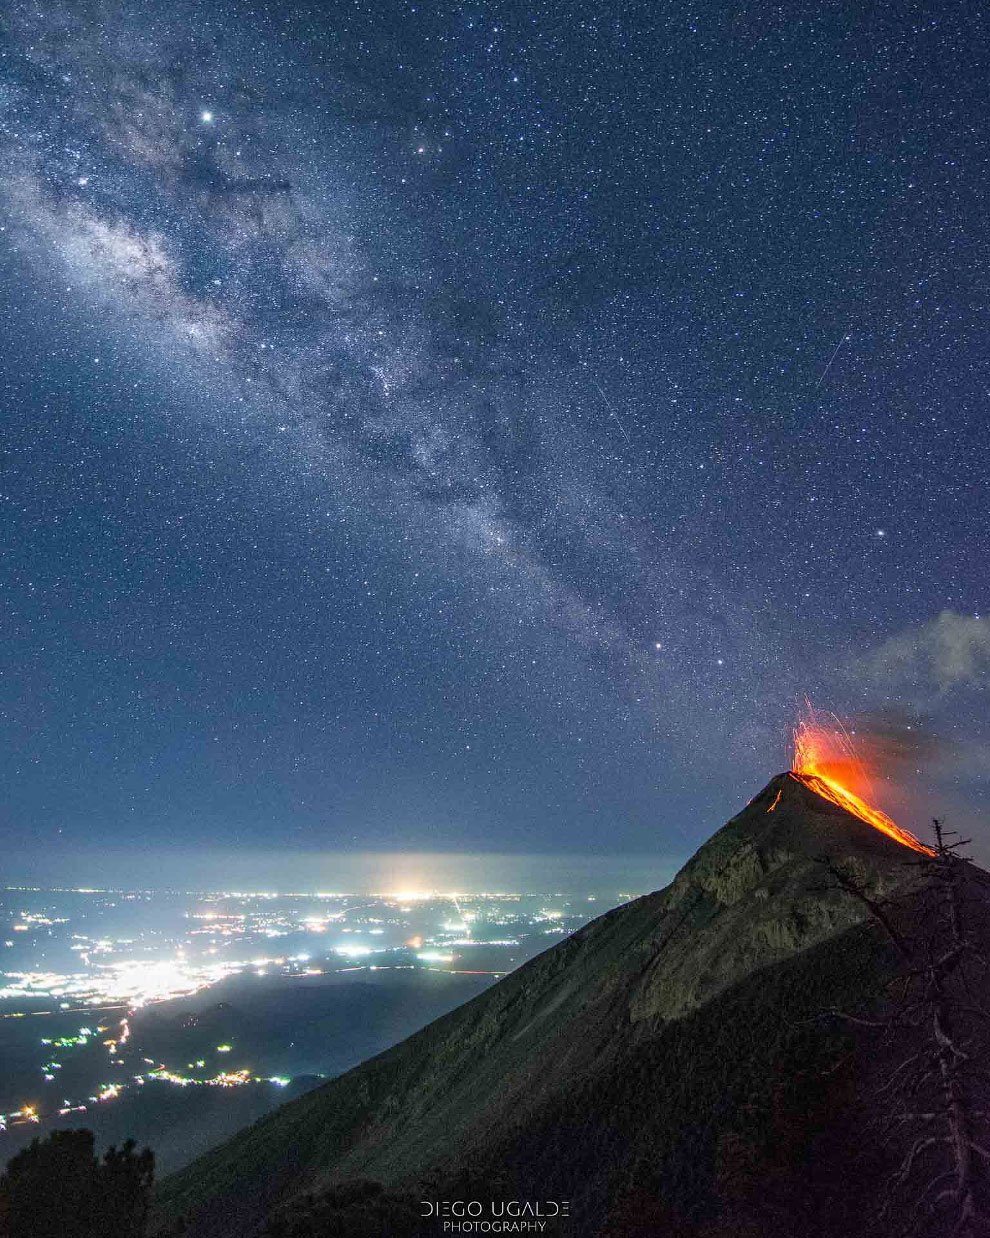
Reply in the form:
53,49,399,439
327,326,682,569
158,773,985,1238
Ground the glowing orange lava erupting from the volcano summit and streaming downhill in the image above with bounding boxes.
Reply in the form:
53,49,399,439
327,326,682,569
775,701,934,855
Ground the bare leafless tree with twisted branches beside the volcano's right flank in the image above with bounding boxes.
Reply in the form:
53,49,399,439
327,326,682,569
828,820,990,1238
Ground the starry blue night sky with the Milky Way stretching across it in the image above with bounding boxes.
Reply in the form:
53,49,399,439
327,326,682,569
0,0,990,871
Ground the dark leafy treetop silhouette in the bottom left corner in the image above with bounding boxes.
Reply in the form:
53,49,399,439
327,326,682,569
0,1130,155,1238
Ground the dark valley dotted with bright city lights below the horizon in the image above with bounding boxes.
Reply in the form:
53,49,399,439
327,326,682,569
0,888,618,1160
